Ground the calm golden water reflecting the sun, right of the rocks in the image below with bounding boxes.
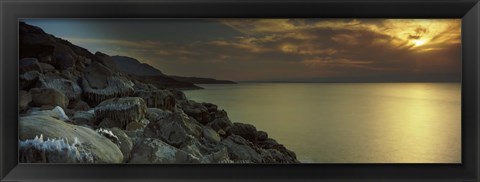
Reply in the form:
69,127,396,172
186,83,461,163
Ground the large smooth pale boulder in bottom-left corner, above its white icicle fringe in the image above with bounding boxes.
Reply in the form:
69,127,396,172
19,115,123,163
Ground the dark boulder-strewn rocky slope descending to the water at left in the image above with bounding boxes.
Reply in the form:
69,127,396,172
19,23,298,163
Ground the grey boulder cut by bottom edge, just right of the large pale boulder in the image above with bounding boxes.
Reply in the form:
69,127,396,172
128,138,200,164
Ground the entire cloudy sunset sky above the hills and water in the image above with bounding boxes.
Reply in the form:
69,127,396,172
22,19,461,82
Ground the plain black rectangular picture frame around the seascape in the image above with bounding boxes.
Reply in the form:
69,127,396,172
0,0,480,182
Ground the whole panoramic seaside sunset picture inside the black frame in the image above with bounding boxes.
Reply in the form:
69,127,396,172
18,18,462,164
